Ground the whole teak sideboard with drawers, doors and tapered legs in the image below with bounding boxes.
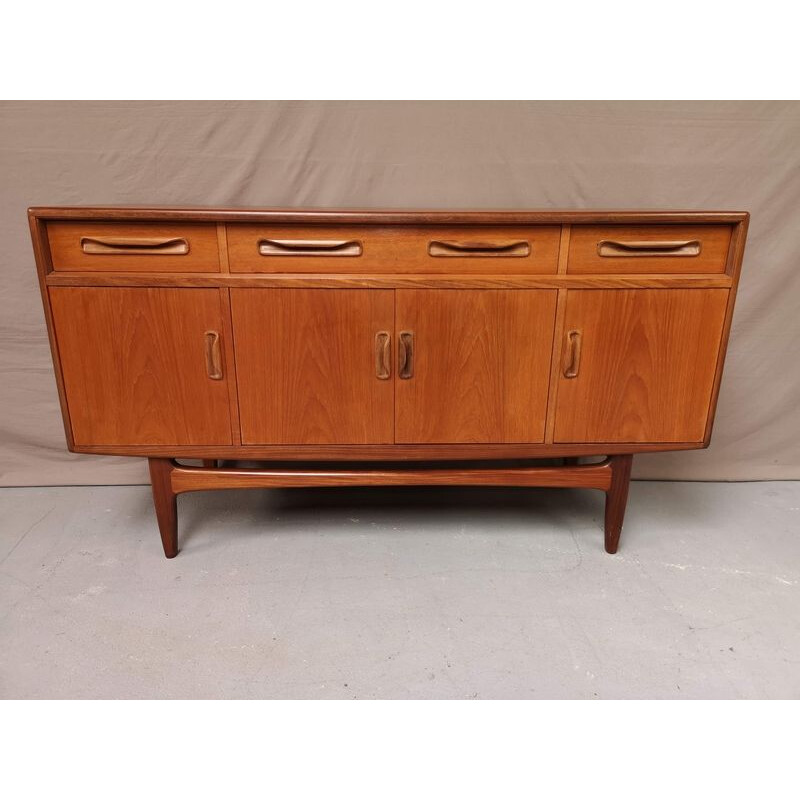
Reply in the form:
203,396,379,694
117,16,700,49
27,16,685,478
28,208,748,558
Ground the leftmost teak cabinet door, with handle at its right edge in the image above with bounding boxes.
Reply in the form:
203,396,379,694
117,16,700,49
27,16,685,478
50,287,231,445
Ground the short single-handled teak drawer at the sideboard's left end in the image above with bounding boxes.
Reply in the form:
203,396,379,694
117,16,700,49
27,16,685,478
47,222,219,272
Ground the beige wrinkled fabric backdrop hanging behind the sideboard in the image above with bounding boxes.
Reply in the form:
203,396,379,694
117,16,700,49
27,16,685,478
0,102,800,485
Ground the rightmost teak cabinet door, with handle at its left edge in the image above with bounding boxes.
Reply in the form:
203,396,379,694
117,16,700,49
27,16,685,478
555,289,728,442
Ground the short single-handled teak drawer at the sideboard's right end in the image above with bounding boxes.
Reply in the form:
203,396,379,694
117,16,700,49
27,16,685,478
567,225,731,275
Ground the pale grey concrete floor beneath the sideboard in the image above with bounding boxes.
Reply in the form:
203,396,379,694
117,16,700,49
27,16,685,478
0,482,800,698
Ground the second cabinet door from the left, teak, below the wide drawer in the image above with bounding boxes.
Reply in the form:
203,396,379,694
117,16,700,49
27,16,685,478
231,289,394,444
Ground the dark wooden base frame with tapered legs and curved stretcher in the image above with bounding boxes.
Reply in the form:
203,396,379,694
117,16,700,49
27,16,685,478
148,454,633,558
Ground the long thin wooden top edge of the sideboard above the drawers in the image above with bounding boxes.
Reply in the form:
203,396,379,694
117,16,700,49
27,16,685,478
28,206,749,225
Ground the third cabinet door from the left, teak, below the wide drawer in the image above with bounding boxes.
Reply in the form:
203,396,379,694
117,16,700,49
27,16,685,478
395,289,556,444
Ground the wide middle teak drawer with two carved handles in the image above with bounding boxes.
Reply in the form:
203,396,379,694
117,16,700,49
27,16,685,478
227,224,561,275
